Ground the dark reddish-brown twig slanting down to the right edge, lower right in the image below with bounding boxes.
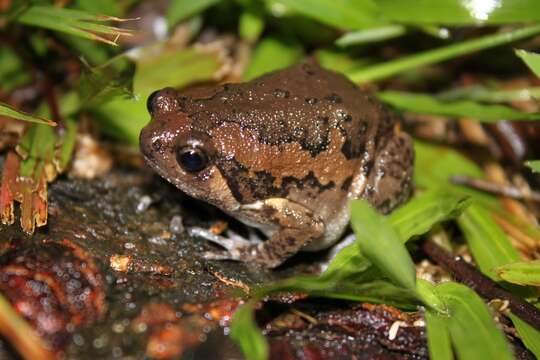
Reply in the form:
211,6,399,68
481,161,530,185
422,240,540,330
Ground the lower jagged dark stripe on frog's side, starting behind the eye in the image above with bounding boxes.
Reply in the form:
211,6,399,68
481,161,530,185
215,159,336,204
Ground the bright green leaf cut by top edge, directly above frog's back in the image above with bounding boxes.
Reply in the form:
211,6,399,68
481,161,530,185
275,0,380,30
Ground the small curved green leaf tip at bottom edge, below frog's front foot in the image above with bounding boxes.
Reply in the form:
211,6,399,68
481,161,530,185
231,302,268,360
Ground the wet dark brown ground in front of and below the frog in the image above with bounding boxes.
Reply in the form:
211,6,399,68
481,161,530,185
0,170,436,359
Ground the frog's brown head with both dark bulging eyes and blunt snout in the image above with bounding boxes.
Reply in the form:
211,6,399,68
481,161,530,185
140,88,237,210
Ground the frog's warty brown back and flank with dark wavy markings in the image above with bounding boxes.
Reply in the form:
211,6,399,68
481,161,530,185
183,64,400,208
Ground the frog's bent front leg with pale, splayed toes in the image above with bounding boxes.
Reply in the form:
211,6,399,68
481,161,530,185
194,198,324,268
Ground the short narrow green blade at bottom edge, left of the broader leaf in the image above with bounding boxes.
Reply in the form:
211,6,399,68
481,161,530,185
425,310,454,360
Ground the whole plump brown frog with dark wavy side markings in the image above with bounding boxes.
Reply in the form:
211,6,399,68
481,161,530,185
140,63,414,268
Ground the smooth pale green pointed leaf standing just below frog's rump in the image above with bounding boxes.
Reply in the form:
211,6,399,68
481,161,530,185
351,200,416,291
